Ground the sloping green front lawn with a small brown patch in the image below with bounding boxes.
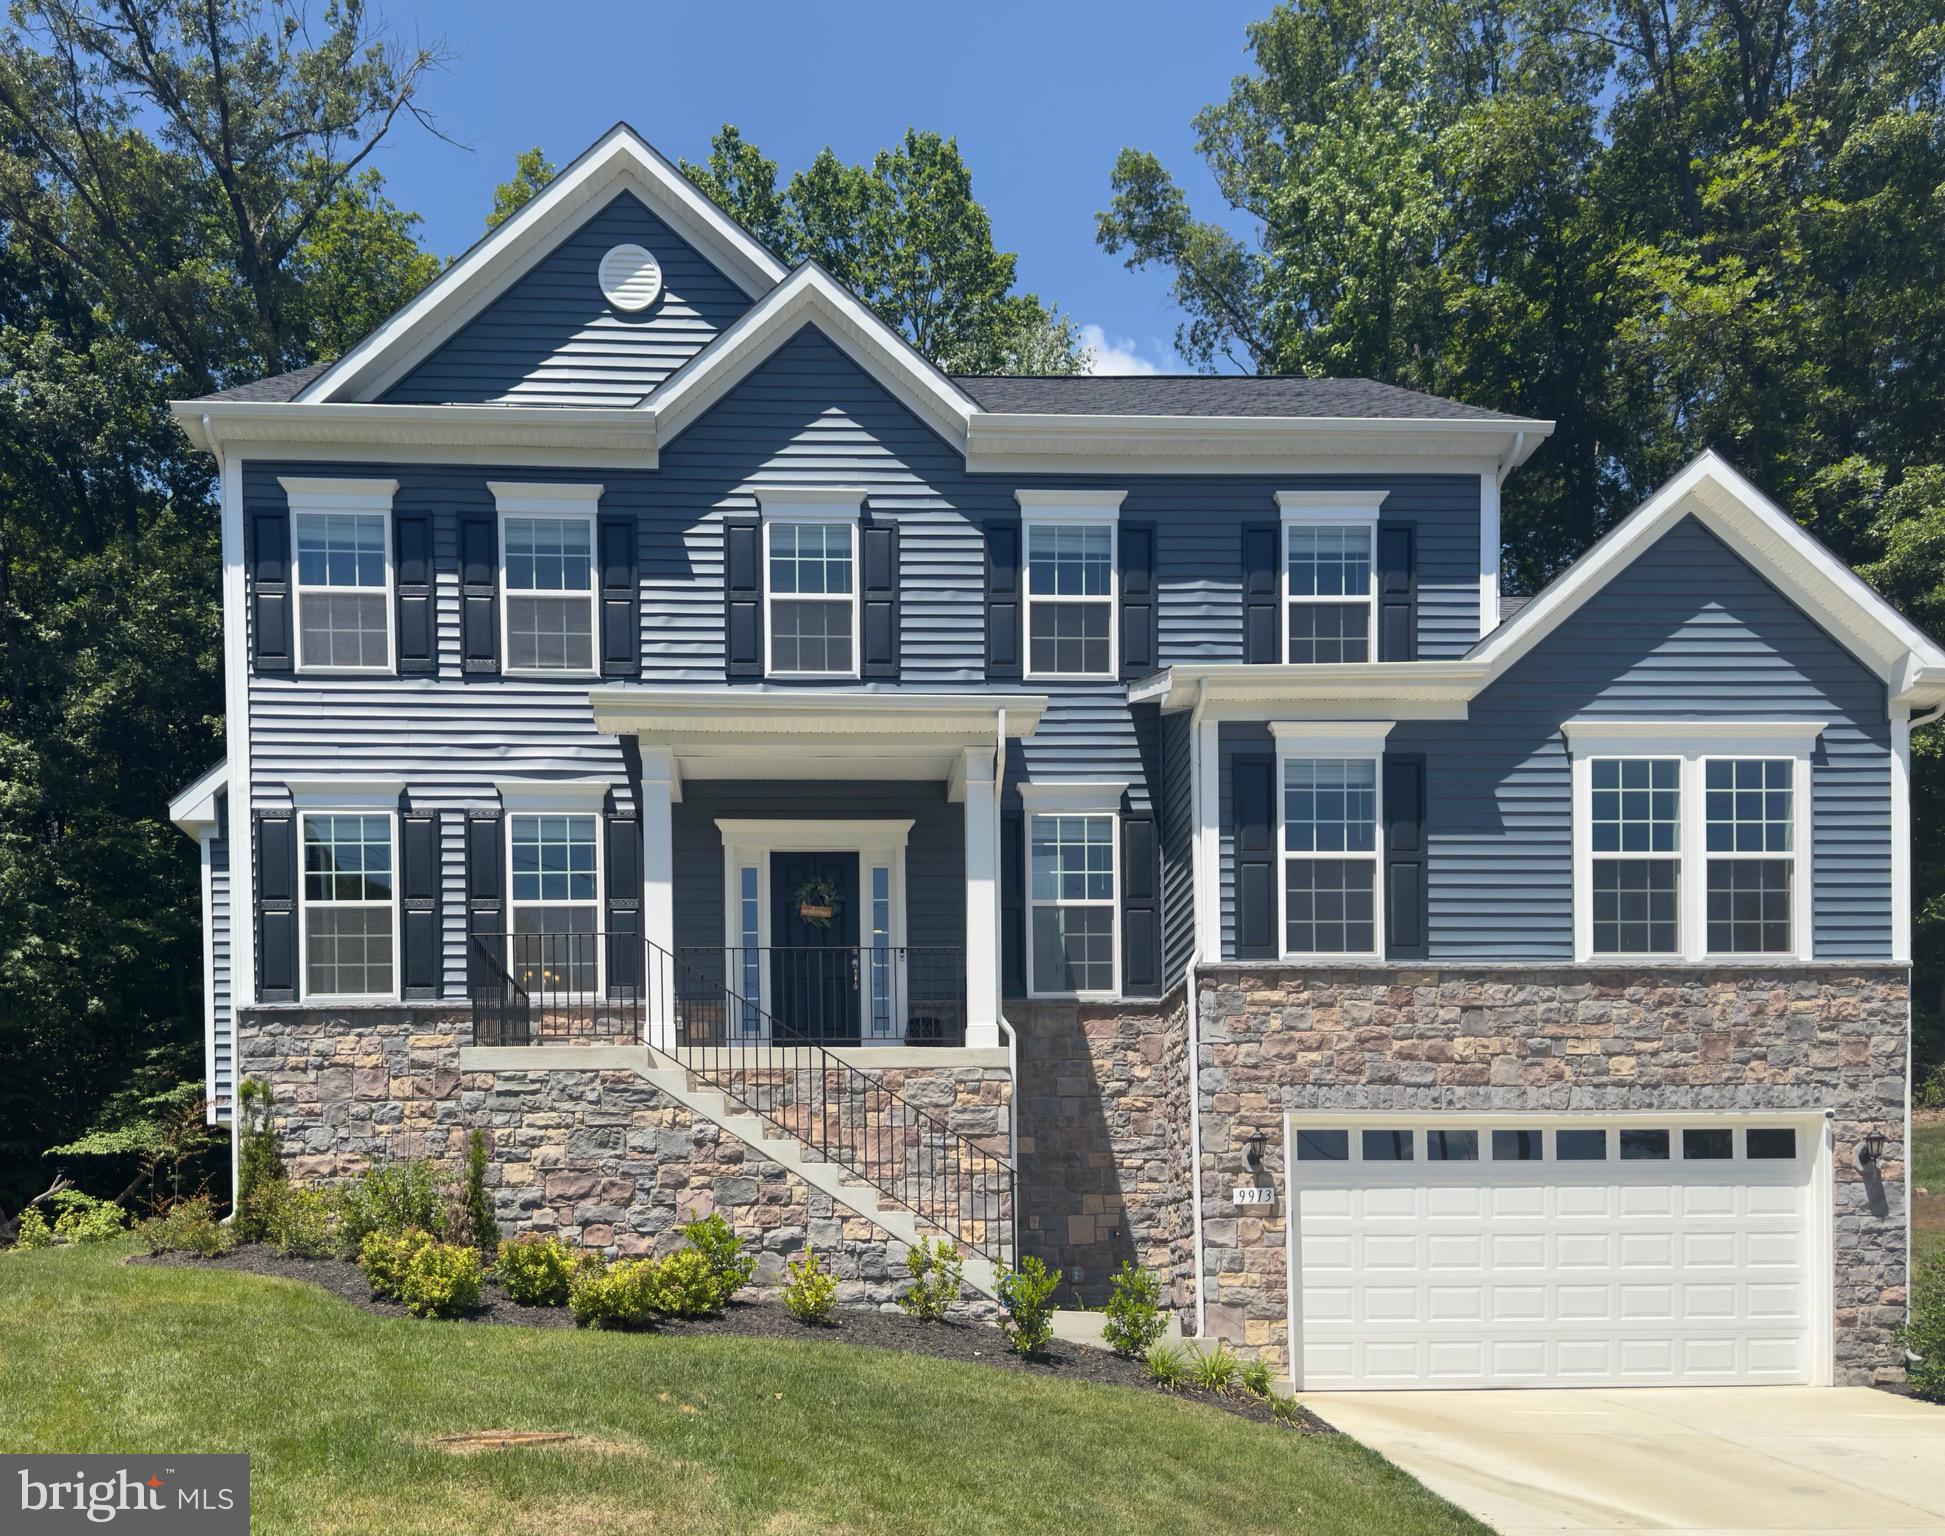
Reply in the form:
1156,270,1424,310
0,1244,1484,1536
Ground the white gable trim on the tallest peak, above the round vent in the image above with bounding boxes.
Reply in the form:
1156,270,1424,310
298,122,786,402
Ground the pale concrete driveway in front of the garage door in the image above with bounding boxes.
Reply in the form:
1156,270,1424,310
1303,1386,1945,1536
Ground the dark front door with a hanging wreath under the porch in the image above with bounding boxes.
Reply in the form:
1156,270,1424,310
770,854,860,1044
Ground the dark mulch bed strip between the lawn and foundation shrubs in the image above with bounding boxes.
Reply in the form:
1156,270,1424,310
128,1242,1336,1435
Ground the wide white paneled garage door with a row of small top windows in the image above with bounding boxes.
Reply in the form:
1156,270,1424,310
1286,1116,1821,1390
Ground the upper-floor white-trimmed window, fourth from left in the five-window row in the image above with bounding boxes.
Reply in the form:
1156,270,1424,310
1019,490,1122,679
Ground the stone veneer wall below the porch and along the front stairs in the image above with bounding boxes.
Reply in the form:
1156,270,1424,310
239,1007,1009,1312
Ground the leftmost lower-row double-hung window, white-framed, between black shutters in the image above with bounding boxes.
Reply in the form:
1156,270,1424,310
298,811,397,997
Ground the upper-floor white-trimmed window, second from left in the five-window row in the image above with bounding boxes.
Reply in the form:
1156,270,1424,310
490,482,601,677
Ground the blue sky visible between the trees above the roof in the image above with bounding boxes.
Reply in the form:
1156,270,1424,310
377,0,1270,371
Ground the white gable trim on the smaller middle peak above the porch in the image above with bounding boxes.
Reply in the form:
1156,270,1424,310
649,266,976,453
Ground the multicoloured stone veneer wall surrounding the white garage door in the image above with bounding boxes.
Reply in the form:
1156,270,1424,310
1198,964,1910,1382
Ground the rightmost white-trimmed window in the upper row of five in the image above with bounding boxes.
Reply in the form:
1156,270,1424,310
1276,490,1385,663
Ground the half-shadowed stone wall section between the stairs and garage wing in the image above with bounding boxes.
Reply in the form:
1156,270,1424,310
1006,988,1194,1312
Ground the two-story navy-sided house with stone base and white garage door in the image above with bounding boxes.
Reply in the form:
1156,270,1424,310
173,126,1945,1388
